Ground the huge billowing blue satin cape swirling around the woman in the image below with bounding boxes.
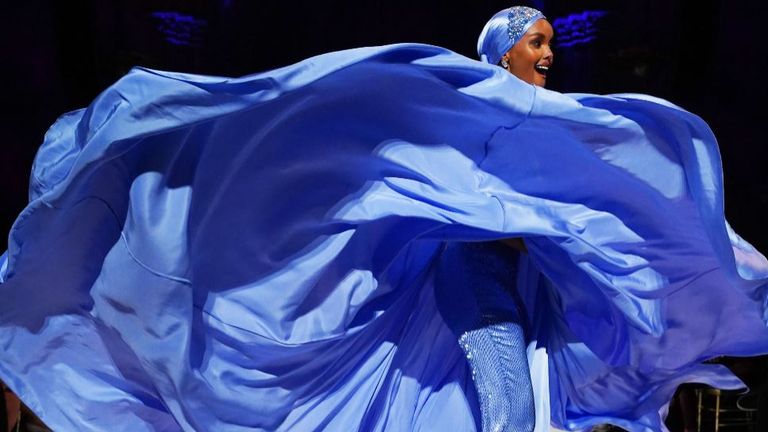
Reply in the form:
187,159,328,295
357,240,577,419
0,44,768,432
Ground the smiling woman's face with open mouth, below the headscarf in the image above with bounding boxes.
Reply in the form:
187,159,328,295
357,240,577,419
501,19,554,87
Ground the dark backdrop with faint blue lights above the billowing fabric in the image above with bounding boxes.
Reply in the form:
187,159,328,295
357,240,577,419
0,0,768,251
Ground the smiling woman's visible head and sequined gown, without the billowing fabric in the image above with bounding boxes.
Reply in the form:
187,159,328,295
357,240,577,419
435,6,554,431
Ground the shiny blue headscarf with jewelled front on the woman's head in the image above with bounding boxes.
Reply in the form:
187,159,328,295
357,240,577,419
477,6,546,65
